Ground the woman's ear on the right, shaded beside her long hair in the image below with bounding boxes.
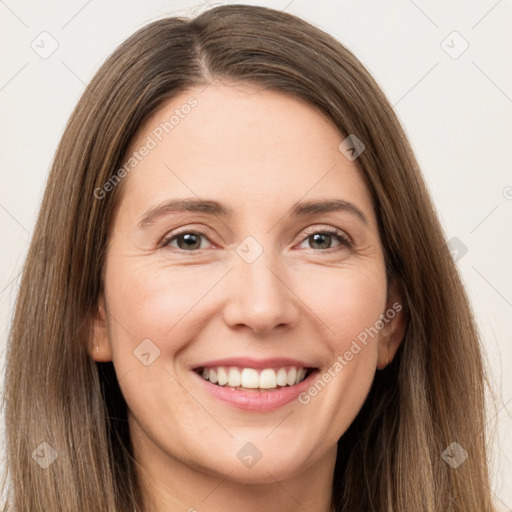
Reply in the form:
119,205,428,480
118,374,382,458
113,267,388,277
377,278,406,370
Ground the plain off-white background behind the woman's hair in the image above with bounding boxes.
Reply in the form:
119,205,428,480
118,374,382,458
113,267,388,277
0,0,512,511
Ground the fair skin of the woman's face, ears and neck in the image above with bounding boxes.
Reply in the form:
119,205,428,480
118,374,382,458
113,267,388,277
91,83,405,512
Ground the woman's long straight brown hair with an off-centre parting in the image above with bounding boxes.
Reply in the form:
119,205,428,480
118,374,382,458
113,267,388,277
3,5,493,512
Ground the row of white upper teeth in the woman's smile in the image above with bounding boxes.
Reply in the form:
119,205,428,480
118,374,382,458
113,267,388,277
202,366,306,389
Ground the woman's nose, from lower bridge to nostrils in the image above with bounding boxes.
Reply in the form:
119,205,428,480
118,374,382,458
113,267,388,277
223,250,300,334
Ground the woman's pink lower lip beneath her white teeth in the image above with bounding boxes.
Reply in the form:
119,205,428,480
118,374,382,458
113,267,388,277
192,370,318,412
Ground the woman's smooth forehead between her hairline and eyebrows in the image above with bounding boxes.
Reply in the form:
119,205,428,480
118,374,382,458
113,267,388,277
116,84,372,226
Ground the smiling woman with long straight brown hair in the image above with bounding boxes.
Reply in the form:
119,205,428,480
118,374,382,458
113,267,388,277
0,5,493,512
